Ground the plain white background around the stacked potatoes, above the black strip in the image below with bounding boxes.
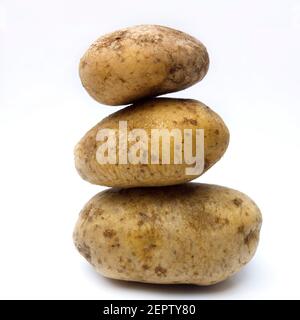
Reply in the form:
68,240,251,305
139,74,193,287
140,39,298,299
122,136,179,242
0,0,300,299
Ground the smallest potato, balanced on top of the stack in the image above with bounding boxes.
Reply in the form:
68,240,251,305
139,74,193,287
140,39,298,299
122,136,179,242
79,25,209,105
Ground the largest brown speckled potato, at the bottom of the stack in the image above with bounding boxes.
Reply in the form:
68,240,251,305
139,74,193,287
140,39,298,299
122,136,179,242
73,183,262,285
